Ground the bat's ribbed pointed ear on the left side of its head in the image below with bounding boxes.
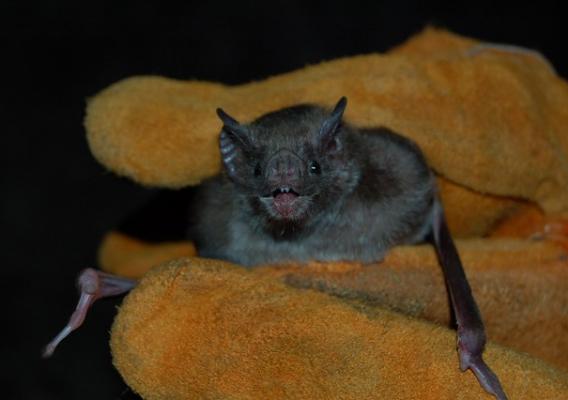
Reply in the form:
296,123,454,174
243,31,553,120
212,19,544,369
217,108,251,179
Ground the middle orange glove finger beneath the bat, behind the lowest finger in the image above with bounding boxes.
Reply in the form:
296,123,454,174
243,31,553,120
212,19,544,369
102,234,568,371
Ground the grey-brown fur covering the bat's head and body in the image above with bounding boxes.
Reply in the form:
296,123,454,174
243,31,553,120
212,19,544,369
190,103,436,266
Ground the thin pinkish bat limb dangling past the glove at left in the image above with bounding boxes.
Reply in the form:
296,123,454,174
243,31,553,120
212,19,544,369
43,268,136,358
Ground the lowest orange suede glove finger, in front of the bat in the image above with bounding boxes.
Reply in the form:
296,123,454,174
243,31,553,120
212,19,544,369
111,259,568,400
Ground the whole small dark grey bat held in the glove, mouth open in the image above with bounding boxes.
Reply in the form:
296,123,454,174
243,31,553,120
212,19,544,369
46,97,506,400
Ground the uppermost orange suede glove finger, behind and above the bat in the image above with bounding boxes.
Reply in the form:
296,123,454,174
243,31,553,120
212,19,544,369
85,30,568,219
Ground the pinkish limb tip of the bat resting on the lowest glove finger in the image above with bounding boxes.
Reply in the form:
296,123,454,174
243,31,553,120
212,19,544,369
458,330,507,400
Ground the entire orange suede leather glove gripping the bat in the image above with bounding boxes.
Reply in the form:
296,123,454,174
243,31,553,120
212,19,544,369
85,29,568,399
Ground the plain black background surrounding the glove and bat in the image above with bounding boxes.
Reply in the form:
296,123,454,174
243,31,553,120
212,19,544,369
0,0,568,399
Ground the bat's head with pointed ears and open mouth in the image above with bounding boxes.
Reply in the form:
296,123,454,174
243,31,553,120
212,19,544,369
217,97,358,236
